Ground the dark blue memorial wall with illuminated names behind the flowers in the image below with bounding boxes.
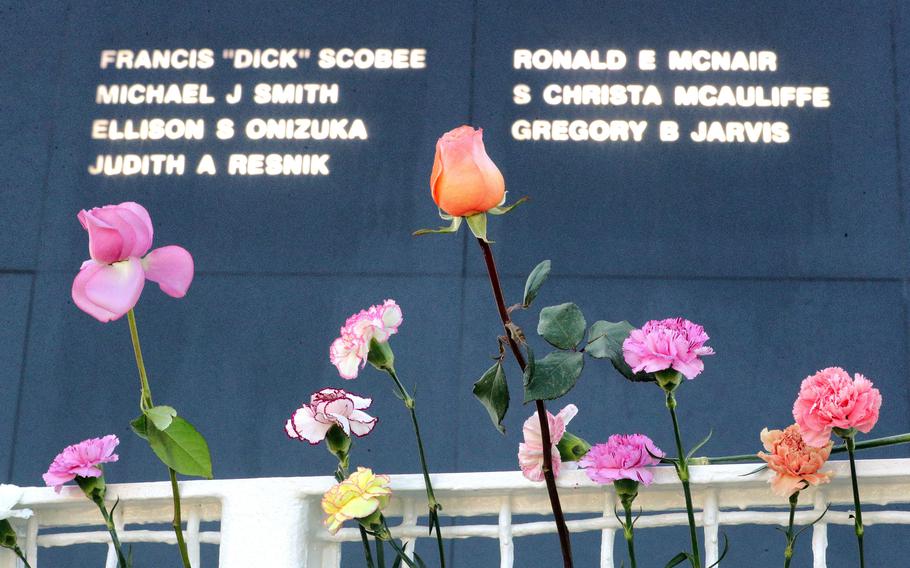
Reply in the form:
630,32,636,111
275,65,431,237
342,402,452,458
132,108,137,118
0,0,910,567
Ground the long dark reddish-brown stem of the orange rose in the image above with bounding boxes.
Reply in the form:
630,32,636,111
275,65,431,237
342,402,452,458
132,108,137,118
477,239,572,568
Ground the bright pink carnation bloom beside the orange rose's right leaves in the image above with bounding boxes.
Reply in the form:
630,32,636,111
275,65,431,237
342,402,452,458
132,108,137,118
622,318,714,379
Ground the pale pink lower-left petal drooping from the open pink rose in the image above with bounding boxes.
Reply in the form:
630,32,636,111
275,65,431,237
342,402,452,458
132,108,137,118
72,258,145,323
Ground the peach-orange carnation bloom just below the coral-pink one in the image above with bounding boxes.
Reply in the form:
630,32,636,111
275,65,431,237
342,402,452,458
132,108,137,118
758,424,834,497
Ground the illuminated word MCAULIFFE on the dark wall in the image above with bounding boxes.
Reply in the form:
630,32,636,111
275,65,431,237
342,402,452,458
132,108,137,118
673,85,831,108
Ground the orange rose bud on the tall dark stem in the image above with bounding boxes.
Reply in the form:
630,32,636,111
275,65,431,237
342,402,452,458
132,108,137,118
430,126,506,217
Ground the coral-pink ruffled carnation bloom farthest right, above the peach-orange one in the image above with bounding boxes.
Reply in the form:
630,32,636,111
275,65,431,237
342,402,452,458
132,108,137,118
793,367,882,448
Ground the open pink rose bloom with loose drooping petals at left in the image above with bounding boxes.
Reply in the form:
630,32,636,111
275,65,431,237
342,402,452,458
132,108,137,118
72,201,193,323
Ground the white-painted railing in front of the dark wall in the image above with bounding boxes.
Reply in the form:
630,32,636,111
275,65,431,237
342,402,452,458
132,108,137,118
0,459,910,568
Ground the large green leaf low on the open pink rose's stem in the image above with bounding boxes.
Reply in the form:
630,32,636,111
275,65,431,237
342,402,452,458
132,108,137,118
146,416,212,479
